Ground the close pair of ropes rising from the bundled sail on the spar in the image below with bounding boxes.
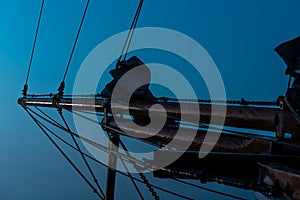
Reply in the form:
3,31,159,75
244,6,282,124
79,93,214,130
117,0,144,68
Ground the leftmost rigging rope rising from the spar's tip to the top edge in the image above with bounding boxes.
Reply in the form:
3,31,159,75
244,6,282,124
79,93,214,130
22,0,45,97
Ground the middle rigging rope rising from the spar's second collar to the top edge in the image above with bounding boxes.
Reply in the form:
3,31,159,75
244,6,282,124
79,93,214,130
58,0,90,97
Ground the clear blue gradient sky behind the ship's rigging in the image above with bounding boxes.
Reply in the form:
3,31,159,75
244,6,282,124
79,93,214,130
0,0,300,200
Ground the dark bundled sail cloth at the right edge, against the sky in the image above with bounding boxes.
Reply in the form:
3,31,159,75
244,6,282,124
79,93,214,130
275,36,300,78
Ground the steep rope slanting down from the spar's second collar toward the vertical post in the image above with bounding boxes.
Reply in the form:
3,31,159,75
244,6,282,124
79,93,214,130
58,108,105,196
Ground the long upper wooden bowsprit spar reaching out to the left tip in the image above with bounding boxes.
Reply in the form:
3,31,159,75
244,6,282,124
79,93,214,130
18,97,300,138
